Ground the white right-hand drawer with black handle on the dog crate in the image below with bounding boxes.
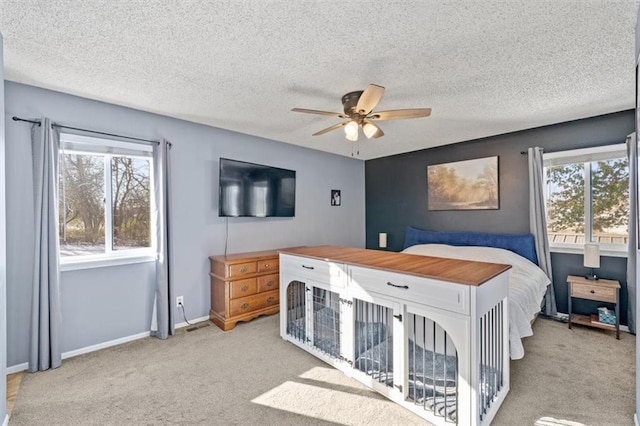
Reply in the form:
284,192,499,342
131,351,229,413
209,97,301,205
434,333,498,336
349,266,470,315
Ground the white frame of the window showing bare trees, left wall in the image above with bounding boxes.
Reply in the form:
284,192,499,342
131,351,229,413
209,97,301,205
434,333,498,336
58,133,157,271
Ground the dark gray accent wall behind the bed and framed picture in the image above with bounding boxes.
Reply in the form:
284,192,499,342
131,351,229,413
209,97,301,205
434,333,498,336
365,110,635,324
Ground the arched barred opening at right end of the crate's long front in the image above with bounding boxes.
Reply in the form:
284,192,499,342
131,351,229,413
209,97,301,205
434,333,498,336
406,313,458,423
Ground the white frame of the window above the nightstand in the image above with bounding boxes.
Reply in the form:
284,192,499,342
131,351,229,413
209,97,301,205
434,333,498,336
543,144,628,257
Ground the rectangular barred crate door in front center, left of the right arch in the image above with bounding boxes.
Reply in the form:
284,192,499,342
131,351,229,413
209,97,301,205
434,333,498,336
354,299,393,387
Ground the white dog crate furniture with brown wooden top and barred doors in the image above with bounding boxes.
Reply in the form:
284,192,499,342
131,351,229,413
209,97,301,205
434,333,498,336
280,246,510,425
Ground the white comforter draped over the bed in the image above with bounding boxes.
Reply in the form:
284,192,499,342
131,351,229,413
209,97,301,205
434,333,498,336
403,244,551,359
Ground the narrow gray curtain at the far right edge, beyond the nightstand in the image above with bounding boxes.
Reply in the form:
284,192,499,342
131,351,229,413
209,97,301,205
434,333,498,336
627,133,638,334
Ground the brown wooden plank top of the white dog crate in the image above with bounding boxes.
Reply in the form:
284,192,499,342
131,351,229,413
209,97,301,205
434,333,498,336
279,246,511,286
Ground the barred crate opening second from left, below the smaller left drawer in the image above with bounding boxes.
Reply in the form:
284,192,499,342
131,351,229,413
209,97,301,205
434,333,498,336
313,287,340,358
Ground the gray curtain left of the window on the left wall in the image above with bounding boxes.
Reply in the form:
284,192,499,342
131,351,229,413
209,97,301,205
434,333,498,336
29,118,62,372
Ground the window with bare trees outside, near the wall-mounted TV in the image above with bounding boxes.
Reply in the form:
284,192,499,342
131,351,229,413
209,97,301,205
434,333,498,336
58,134,152,263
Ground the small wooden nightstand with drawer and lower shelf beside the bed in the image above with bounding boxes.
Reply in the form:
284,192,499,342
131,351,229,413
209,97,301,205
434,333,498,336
567,275,620,339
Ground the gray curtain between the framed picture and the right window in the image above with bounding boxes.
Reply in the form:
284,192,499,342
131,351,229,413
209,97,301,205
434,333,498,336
528,147,558,316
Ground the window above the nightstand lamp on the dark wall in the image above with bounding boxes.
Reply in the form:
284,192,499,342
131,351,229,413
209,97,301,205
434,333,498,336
544,145,629,255
